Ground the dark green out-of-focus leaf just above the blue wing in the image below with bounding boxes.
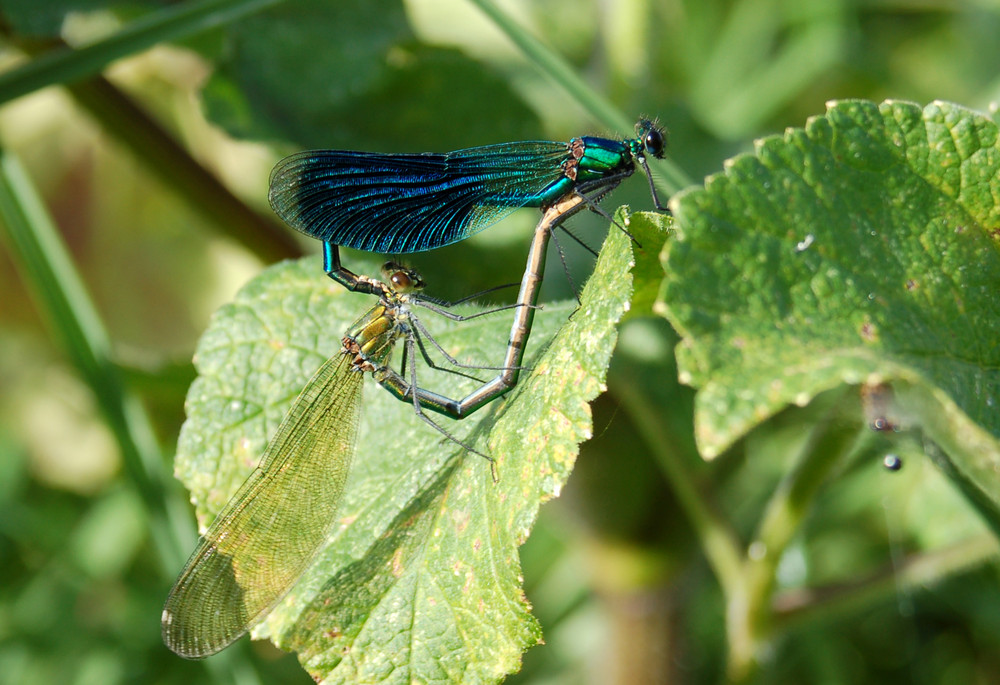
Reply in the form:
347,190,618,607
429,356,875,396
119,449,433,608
204,0,538,151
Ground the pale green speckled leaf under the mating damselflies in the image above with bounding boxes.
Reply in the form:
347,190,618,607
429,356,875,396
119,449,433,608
176,214,662,683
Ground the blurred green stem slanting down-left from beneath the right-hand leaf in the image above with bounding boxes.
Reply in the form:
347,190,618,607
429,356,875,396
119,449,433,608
726,388,867,682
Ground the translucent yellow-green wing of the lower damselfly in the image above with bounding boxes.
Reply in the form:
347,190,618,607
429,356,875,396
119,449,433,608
162,353,364,658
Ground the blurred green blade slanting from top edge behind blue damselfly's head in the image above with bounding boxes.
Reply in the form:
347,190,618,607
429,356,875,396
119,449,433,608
471,0,691,195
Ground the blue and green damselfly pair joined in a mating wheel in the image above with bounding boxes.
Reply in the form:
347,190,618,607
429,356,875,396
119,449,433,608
162,121,664,658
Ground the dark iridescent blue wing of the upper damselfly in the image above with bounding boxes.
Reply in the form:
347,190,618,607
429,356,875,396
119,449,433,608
269,141,570,254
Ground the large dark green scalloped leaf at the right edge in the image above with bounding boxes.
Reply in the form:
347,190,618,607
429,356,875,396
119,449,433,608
662,101,1000,521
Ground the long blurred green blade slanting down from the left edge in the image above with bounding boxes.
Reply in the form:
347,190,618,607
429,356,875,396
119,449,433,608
0,149,194,576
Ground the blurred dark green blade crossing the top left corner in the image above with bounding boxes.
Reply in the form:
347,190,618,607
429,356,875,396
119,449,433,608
0,0,281,104
